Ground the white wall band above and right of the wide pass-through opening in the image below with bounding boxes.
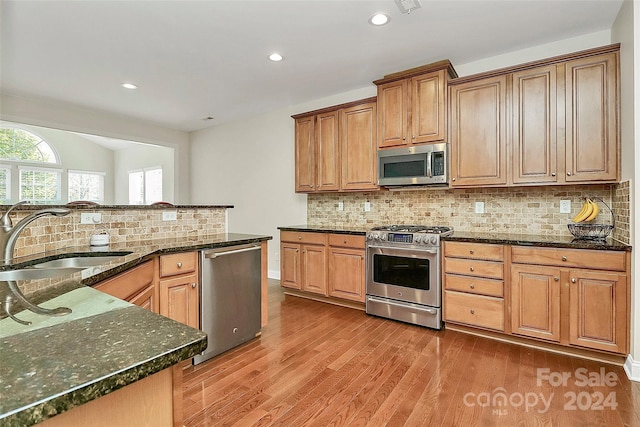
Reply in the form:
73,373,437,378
0,93,191,204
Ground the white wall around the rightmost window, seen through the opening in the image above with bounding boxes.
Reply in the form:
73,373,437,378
114,144,176,205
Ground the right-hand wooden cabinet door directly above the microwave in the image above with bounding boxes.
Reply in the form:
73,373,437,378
408,70,447,144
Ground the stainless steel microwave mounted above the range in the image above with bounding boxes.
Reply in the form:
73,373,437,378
378,142,449,187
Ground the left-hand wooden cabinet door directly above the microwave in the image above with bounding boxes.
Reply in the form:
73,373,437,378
377,80,408,148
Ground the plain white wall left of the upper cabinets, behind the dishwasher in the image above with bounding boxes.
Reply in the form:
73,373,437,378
191,85,376,278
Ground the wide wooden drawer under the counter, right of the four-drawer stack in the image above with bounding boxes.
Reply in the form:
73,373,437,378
511,246,626,271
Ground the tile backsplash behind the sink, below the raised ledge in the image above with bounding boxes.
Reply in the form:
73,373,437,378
11,208,226,257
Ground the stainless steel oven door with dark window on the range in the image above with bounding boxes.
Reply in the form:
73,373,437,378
367,245,442,307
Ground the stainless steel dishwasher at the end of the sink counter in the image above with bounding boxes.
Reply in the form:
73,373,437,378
193,245,262,365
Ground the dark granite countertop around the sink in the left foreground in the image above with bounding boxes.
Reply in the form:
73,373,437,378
0,233,272,427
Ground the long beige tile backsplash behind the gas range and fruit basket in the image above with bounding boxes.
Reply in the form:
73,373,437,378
307,182,629,244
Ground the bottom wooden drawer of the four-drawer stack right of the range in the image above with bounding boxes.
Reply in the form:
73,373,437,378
444,291,504,332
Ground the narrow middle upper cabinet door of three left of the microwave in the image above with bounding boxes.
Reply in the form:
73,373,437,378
315,111,340,191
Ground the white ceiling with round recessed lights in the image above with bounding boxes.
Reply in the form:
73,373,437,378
0,0,622,131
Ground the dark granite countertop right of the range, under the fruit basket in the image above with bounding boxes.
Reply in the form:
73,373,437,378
443,230,631,251
